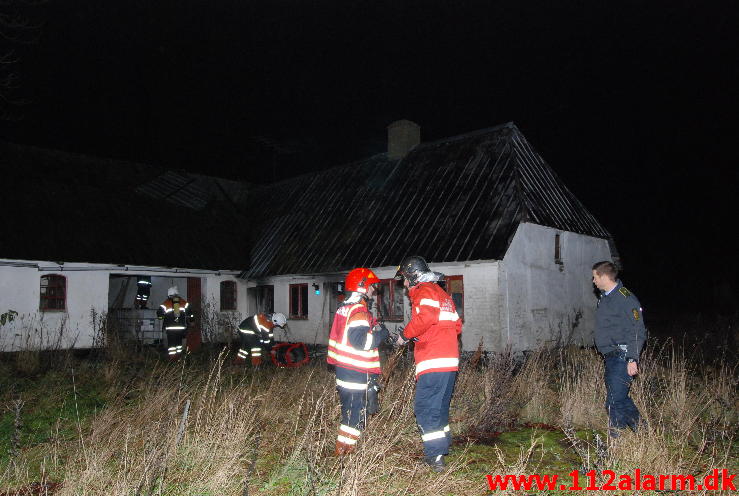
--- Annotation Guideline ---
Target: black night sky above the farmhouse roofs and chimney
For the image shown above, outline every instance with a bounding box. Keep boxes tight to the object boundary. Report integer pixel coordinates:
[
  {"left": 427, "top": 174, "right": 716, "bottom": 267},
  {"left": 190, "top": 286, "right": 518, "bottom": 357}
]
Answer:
[{"left": 0, "top": 0, "right": 739, "bottom": 308}]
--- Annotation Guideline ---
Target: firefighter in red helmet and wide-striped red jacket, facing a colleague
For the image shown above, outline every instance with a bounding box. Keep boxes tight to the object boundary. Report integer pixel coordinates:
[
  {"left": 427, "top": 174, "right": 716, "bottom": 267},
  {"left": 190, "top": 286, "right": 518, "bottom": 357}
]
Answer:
[{"left": 327, "top": 267, "right": 388, "bottom": 455}]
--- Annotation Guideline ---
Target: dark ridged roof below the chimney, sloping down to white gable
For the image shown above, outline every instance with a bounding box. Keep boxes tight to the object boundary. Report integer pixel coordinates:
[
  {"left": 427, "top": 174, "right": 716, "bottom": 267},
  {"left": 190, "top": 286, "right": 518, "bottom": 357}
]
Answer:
[{"left": 242, "top": 123, "right": 610, "bottom": 278}]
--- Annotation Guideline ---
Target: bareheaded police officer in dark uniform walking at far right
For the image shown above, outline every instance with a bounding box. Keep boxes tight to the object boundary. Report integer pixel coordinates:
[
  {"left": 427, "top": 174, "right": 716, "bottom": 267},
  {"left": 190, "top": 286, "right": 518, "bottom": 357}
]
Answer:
[{"left": 593, "top": 261, "right": 646, "bottom": 437}]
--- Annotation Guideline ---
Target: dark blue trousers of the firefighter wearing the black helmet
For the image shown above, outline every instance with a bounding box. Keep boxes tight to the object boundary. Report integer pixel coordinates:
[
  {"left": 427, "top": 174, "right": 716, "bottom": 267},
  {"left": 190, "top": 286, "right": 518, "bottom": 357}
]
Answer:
[{"left": 414, "top": 372, "right": 457, "bottom": 458}]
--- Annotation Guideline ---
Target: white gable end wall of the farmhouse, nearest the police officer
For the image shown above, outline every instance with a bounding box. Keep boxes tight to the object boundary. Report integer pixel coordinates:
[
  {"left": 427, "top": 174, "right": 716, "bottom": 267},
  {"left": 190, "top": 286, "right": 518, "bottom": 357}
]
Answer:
[{"left": 500, "top": 223, "right": 611, "bottom": 351}]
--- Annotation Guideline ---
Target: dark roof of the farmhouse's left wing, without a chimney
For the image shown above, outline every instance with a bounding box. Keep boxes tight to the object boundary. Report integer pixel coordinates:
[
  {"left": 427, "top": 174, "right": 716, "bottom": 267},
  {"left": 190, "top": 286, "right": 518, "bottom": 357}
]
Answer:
[{"left": 0, "top": 141, "right": 249, "bottom": 270}]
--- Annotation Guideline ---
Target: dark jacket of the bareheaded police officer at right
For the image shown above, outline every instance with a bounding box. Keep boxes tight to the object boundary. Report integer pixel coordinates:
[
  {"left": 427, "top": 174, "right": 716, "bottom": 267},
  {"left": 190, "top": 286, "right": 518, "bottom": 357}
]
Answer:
[{"left": 595, "top": 281, "right": 647, "bottom": 360}]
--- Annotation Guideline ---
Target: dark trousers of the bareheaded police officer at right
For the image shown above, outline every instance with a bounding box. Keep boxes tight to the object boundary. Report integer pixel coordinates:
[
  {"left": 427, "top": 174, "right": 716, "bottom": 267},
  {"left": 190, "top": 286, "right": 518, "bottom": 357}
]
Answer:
[{"left": 605, "top": 356, "right": 641, "bottom": 430}]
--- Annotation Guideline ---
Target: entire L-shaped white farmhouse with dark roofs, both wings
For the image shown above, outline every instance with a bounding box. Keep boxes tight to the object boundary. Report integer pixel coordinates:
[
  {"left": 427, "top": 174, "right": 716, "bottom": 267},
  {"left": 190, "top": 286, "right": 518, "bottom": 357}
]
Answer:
[{"left": 0, "top": 120, "right": 617, "bottom": 351}]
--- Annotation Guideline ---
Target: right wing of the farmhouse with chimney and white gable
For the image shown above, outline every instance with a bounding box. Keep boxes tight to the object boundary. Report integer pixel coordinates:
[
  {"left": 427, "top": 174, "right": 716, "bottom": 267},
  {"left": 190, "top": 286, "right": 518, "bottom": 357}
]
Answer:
[{"left": 241, "top": 120, "right": 616, "bottom": 351}]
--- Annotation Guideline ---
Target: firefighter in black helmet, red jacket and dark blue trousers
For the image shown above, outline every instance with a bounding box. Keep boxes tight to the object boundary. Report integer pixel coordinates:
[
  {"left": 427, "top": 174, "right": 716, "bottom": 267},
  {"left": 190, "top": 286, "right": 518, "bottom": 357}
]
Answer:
[{"left": 396, "top": 256, "right": 462, "bottom": 472}]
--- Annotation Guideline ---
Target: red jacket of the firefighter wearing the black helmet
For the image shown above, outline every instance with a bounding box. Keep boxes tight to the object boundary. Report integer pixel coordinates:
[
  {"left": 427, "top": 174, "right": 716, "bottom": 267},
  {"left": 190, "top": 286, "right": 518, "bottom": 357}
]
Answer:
[{"left": 403, "top": 282, "right": 462, "bottom": 378}]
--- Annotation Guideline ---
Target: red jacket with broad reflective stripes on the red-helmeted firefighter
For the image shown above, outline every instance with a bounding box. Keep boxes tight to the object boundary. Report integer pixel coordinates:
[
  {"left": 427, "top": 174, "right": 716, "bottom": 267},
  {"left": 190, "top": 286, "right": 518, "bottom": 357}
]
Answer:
[{"left": 327, "top": 302, "right": 385, "bottom": 374}]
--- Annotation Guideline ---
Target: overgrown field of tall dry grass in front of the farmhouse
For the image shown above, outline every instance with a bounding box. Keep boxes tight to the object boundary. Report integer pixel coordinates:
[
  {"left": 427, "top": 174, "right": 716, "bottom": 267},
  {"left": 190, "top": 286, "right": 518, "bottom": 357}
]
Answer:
[{"left": 0, "top": 334, "right": 739, "bottom": 496}]
